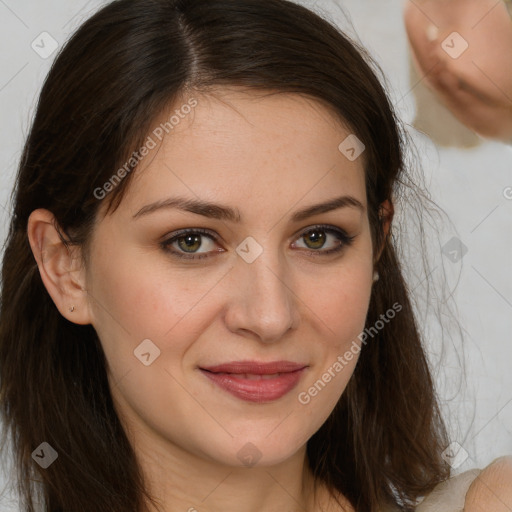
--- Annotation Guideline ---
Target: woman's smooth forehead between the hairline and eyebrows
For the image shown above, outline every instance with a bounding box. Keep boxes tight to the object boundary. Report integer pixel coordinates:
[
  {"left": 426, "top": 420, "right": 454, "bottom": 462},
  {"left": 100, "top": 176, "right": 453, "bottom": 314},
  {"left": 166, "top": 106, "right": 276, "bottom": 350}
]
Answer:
[{"left": 106, "top": 89, "right": 366, "bottom": 220}]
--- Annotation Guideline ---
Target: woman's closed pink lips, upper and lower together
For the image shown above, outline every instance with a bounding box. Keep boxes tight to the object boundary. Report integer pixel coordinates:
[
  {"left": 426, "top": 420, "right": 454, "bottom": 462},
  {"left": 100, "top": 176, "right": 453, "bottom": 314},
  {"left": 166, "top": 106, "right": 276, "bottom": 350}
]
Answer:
[{"left": 200, "top": 361, "right": 307, "bottom": 403}]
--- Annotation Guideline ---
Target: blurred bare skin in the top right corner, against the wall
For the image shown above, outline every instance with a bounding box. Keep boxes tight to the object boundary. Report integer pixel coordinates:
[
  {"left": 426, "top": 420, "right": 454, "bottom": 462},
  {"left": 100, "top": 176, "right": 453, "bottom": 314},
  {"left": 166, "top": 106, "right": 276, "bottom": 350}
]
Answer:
[{"left": 404, "top": 0, "right": 512, "bottom": 142}]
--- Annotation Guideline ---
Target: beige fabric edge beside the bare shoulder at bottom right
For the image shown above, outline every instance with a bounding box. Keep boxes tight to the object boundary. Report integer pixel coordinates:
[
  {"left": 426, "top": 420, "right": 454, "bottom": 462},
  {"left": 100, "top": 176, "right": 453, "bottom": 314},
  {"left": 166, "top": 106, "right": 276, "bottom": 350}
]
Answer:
[{"left": 416, "top": 469, "right": 482, "bottom": 512}]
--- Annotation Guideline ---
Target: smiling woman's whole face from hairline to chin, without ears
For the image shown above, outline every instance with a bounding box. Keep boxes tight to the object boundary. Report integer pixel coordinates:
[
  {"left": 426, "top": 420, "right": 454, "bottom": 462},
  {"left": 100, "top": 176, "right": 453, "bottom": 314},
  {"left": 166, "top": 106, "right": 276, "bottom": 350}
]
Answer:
[{"left": 86, "top": 90, "right": 373, "bottom": 466}]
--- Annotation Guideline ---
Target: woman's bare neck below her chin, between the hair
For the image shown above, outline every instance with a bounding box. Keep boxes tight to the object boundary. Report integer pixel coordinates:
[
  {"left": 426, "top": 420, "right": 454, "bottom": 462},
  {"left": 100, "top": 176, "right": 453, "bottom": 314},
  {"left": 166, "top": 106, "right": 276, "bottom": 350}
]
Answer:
[{"left": 137, "top": 432, "right": 316, "bottom": 512}]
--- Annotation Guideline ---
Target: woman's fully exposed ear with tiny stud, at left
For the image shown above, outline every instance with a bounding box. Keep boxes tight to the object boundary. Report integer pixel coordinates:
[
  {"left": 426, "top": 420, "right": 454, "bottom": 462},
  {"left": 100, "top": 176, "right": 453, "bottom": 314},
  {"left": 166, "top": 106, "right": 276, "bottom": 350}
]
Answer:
[{"left": 27, "top": 208, "right": 92, "bottom": 325}]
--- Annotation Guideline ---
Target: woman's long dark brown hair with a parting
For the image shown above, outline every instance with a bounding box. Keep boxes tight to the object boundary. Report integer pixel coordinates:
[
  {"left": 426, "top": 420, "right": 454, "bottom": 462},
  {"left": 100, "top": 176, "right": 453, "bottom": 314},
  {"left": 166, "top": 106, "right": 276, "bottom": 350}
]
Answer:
[{"left": 0, "top": 0, "right": 449, "bottom": 512}]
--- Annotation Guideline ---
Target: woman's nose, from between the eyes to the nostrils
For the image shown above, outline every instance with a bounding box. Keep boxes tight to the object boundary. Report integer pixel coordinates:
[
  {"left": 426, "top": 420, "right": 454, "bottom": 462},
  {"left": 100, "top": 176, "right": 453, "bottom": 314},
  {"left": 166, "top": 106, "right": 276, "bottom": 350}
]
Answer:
[{"left": 225, "top": 244, "right": 300, "bottom": 343}]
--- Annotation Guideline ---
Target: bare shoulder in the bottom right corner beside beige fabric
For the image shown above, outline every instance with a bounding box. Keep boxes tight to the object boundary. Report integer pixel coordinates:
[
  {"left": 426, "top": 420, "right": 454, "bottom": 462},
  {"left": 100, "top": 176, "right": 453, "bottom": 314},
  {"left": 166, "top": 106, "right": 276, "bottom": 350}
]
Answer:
[{"left": 464, "top": 455, "right": 512, "bottom": 512}]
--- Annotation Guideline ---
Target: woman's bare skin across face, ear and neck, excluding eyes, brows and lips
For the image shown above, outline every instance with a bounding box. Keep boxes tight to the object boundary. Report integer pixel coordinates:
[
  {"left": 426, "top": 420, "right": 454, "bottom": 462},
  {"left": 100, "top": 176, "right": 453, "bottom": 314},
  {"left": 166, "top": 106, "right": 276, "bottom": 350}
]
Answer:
[{"left": 28, "top": 89, "right": 392, "bottom": 512}]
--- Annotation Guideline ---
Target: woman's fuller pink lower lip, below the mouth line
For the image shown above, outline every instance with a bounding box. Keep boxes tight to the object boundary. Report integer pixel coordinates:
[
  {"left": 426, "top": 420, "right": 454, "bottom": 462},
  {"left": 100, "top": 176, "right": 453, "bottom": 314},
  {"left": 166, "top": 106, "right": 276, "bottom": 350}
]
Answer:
[{"left": 200, "top": 368, "right": 306, "bottom": 403}]
